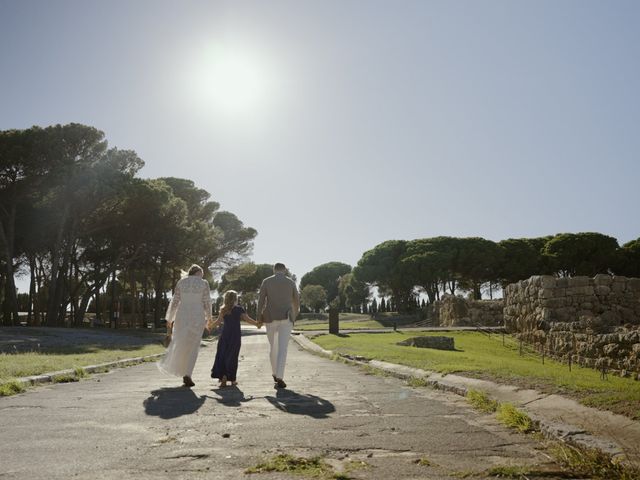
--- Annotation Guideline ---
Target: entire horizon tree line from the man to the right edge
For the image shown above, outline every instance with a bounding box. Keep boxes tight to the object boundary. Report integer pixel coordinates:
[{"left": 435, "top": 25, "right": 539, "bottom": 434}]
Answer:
[{"left": 236, "top": 232, "right": 640, "bottom": 313}]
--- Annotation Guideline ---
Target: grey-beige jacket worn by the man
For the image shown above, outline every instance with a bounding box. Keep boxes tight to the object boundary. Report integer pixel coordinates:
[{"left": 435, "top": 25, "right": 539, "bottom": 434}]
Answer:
[{"left": 258, "top": 272, "right": 300, "bottom": 323}]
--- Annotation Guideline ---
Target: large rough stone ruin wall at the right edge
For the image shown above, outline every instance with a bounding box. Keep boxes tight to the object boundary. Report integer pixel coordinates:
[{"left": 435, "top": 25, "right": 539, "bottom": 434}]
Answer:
[{"left": 504, "top": 275, "right": 640, "bottom": 379}]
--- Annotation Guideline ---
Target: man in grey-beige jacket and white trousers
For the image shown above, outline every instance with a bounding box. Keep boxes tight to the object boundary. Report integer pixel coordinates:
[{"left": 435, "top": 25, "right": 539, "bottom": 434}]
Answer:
[{"left": 257, "top": 263, "right": 300, "bottom": 388}]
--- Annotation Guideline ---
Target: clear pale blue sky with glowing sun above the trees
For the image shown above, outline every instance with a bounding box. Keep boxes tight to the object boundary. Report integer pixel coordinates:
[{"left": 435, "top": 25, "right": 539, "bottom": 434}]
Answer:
[{"left": 0, "top": 0, "right": 640, "bottom": 284}]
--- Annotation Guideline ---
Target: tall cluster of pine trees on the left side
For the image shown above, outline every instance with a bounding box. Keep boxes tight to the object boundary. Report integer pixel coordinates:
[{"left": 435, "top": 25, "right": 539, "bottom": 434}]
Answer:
[{"left": 0, "top": 123, "right": 257, "bottom": 325}]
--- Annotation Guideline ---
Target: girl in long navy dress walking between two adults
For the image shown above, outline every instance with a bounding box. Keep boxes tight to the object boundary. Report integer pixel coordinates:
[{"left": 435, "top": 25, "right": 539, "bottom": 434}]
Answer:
[{"left": 211, "top": 290, "right": 262, "bottom": 387}]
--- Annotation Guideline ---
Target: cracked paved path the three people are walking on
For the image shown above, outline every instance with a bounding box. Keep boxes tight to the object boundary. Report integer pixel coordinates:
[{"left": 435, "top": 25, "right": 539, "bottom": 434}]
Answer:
[{"left": 0, "top": 331, "right": 564, "bottom": 480}]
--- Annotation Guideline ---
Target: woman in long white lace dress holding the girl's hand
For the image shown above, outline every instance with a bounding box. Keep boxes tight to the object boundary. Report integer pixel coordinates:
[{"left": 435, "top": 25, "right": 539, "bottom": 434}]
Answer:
[{"left": 158, "top": 265, "right": 211, "bottom": 387}]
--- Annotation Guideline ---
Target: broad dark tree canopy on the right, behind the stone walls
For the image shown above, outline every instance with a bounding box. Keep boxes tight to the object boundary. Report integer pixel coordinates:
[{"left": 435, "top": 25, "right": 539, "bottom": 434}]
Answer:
[{"left": 353, "top": 232, "right": 640, "bottom": 311}]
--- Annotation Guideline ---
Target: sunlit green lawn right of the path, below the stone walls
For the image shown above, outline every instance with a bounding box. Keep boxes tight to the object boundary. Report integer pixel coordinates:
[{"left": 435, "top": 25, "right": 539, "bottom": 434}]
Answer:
[{"left": 313, "top": 332, "right": 640, "bottom": 420}]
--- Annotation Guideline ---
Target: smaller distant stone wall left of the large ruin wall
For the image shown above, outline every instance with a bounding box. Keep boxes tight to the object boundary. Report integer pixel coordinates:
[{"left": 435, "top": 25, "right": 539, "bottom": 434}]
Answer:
[{"left": 433, "top": 295, "right": 503, "bottom": 327}]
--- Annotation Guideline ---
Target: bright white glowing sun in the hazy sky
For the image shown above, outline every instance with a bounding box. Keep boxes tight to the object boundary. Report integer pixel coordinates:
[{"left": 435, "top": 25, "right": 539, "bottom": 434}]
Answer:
[{"left": 191, "top": 45, "right": 271, "bottom": 115}]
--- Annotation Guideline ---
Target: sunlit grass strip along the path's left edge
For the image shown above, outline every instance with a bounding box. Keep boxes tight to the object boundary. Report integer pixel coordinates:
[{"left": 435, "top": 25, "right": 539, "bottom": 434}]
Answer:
[{"left": 0, "top": 344, "right": 164, "bottom": 384}]
